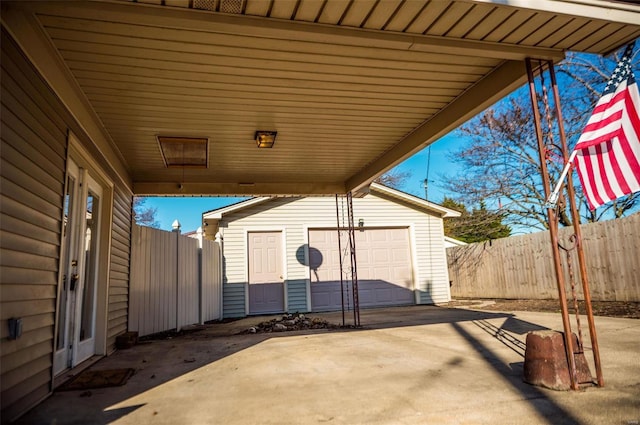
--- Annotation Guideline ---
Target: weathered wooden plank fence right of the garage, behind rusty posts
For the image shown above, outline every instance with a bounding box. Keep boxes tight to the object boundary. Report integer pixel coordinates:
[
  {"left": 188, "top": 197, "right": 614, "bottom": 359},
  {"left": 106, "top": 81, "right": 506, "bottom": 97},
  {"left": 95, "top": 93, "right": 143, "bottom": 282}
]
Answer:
[{"left": 447, "top": 213, "right": 640, "bottom": 301}]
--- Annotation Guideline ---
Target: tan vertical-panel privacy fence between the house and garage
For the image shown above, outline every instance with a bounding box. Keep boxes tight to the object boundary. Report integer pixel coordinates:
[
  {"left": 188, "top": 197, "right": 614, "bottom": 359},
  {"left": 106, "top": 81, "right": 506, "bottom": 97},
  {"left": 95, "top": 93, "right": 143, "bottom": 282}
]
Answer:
[{"left": 129, "top": 225, "right": 222, "bottom": 336}]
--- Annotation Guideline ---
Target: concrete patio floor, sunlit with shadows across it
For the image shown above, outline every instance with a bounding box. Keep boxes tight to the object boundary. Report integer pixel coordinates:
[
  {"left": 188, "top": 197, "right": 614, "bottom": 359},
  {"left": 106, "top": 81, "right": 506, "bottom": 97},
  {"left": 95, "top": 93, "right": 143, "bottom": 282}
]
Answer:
[{"left": 18, "top": 306, "right": 640, "bottom": 425}]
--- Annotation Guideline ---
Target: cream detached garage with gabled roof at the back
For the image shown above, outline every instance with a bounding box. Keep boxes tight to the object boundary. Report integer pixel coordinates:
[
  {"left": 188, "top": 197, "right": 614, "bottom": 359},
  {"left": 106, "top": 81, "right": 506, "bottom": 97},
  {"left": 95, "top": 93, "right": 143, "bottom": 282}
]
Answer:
[{"left": 203, "top": 183, "right": 459, "bottom": 317}]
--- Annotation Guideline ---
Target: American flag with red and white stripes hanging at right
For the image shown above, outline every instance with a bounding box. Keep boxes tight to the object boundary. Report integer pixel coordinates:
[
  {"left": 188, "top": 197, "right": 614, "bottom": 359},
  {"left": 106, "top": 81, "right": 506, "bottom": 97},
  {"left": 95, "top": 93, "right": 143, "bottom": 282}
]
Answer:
[{"left": 574, "top": 42, "right": 640, "bottom": 210}]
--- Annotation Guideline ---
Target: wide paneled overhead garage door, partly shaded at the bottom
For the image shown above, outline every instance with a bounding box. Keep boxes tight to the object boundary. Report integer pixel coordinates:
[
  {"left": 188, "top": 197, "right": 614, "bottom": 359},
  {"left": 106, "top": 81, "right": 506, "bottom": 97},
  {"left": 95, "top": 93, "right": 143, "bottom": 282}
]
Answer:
[{"left": 309, "top": 228, "right": 415, "bottom": 311}]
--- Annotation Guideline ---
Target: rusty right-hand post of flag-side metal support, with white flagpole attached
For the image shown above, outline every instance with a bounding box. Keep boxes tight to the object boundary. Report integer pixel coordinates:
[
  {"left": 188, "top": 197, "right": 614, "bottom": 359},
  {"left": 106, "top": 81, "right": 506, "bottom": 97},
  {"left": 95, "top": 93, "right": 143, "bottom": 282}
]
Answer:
[{"left": 549, "top": 62, "right": 604, "bottom": 387}]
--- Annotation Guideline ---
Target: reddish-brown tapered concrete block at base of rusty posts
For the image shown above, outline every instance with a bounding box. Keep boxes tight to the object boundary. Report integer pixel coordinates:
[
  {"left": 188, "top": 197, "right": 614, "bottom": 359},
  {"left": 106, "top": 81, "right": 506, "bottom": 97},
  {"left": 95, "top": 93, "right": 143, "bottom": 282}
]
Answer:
[{"left": 524, "top": 330, "right": 593, "bottom": 391}]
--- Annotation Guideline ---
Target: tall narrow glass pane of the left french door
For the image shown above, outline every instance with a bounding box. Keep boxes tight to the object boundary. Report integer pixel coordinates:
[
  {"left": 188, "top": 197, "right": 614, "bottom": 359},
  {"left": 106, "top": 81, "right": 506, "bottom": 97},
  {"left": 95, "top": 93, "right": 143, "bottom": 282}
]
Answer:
[{"left": 56, "top": 176, "right": 76, "bottom": 350}]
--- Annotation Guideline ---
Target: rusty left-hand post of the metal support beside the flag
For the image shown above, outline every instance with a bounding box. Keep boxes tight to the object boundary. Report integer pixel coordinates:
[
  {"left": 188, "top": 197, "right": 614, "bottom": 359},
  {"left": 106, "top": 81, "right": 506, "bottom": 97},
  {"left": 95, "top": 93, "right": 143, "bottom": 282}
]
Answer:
[{"left": 525, "top": 58, "right": 578, "bottom": 390}]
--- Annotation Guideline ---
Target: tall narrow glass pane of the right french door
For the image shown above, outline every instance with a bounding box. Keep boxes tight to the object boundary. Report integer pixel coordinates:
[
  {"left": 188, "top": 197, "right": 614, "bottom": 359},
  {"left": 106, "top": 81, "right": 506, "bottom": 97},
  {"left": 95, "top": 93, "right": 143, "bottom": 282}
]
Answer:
[{"left": 80, "top": 190, "right": 100, "bottom": 341}]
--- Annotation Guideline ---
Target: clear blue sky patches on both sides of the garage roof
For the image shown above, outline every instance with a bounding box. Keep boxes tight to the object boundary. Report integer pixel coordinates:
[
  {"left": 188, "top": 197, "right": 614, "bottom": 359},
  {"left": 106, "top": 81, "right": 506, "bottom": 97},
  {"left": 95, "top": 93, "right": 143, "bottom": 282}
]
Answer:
[{"left": 145, "top": 133, "right": 462, "bottom": 233}]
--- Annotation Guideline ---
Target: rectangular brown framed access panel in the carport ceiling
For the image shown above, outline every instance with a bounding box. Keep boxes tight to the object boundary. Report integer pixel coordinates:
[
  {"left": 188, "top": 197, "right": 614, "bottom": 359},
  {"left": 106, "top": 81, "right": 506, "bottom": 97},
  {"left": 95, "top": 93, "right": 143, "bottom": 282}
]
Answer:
[{"left": 158, "top": 136, "right": 209, "bottom": 168}]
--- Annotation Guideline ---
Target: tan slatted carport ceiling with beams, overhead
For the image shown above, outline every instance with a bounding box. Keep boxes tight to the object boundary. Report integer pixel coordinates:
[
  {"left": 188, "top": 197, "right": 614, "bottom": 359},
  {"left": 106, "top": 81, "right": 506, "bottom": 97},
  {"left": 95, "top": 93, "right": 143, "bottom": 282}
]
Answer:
[{"left": 3, "top": 0, "right": 640, "bottom": 195}]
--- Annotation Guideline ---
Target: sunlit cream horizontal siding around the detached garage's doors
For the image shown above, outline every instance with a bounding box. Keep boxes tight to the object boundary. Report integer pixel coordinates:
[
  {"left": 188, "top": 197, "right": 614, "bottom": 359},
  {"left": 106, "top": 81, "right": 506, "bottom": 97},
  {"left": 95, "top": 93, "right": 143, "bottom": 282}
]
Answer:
[{"left": 220, "top": 194, "right": 449, "bottom": 312}]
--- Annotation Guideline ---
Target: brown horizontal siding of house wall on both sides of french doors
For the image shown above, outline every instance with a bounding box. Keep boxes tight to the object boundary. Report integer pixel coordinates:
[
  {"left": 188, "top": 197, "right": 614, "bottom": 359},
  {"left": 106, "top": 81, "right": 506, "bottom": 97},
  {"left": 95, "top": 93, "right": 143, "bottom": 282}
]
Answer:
[{"left": 0, "top": 27, "right": 132, "bottom": 421}]
